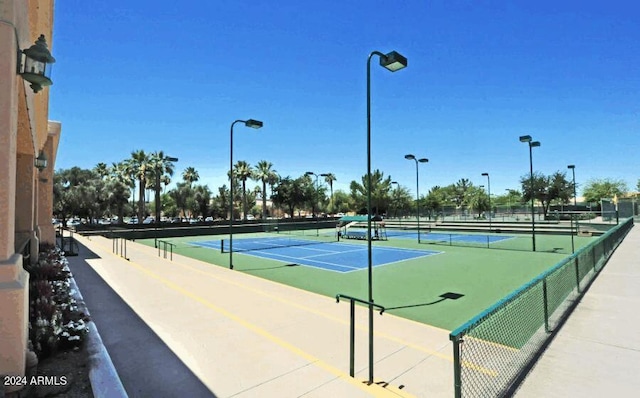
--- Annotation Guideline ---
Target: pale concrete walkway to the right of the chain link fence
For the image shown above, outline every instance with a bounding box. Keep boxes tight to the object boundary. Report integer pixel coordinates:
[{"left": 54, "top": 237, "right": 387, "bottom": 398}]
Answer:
[{"left": 516, "top": 226, "right": 640, "bottom": 398}]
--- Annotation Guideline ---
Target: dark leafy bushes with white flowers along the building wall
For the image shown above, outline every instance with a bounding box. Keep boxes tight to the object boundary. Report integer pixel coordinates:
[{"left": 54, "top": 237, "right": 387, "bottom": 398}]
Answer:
[{"left": 25, "top": 246, "right": 89, "bottom": 360}]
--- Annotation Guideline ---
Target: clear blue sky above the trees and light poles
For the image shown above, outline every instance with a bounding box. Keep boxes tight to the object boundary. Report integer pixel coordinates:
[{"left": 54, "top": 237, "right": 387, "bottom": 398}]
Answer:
[{"left": 50, "top": 0, "right": 640, "bottom": 199}]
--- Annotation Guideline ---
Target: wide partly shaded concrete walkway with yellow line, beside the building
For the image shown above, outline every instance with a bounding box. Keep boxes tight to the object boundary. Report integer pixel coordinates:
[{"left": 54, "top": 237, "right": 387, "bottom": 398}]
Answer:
[{"left": 72, "top": 235, "right": 453, "bottom": 398}]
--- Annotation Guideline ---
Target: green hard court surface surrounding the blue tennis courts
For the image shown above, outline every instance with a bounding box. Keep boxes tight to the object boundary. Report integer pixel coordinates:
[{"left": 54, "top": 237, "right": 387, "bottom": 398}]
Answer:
[{"left": 138, "top": 229, "right": 595, "bottom": 330}]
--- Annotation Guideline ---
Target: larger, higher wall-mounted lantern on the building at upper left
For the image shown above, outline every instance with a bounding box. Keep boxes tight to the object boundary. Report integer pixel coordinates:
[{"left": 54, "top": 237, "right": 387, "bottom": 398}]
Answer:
[{"left": 18, "top": 35, "right": 56, "bottom": 93}]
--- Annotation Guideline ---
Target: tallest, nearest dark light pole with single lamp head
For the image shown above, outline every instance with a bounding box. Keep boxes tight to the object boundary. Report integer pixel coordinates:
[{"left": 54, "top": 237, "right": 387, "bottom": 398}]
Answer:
[{"left": 367, "top": 51, "right": 407, "bottom": 384}]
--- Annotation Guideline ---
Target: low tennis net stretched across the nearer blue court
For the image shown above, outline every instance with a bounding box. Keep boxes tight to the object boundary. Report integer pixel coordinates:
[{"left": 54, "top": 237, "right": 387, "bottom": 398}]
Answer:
[{"left": 220, "top": 233, "right": 339, "bottom": 253}]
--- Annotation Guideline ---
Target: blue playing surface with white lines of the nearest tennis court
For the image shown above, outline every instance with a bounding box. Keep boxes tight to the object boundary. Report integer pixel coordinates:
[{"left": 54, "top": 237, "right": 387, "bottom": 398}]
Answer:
[{"left": 191, "top": 238, "right": 441, "bottom": 272}]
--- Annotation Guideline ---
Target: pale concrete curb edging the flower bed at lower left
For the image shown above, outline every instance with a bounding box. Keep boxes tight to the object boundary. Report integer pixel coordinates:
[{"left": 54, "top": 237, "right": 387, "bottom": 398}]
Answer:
[{"left": 69, "top": 277, "right": 129, "bottom": 398}]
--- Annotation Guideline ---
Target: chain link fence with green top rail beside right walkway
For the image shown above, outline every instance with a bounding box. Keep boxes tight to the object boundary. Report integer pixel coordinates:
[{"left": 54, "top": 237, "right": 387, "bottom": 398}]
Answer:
[{"left": 449, "top": 218, "right": 633, "bottom": 397}]
